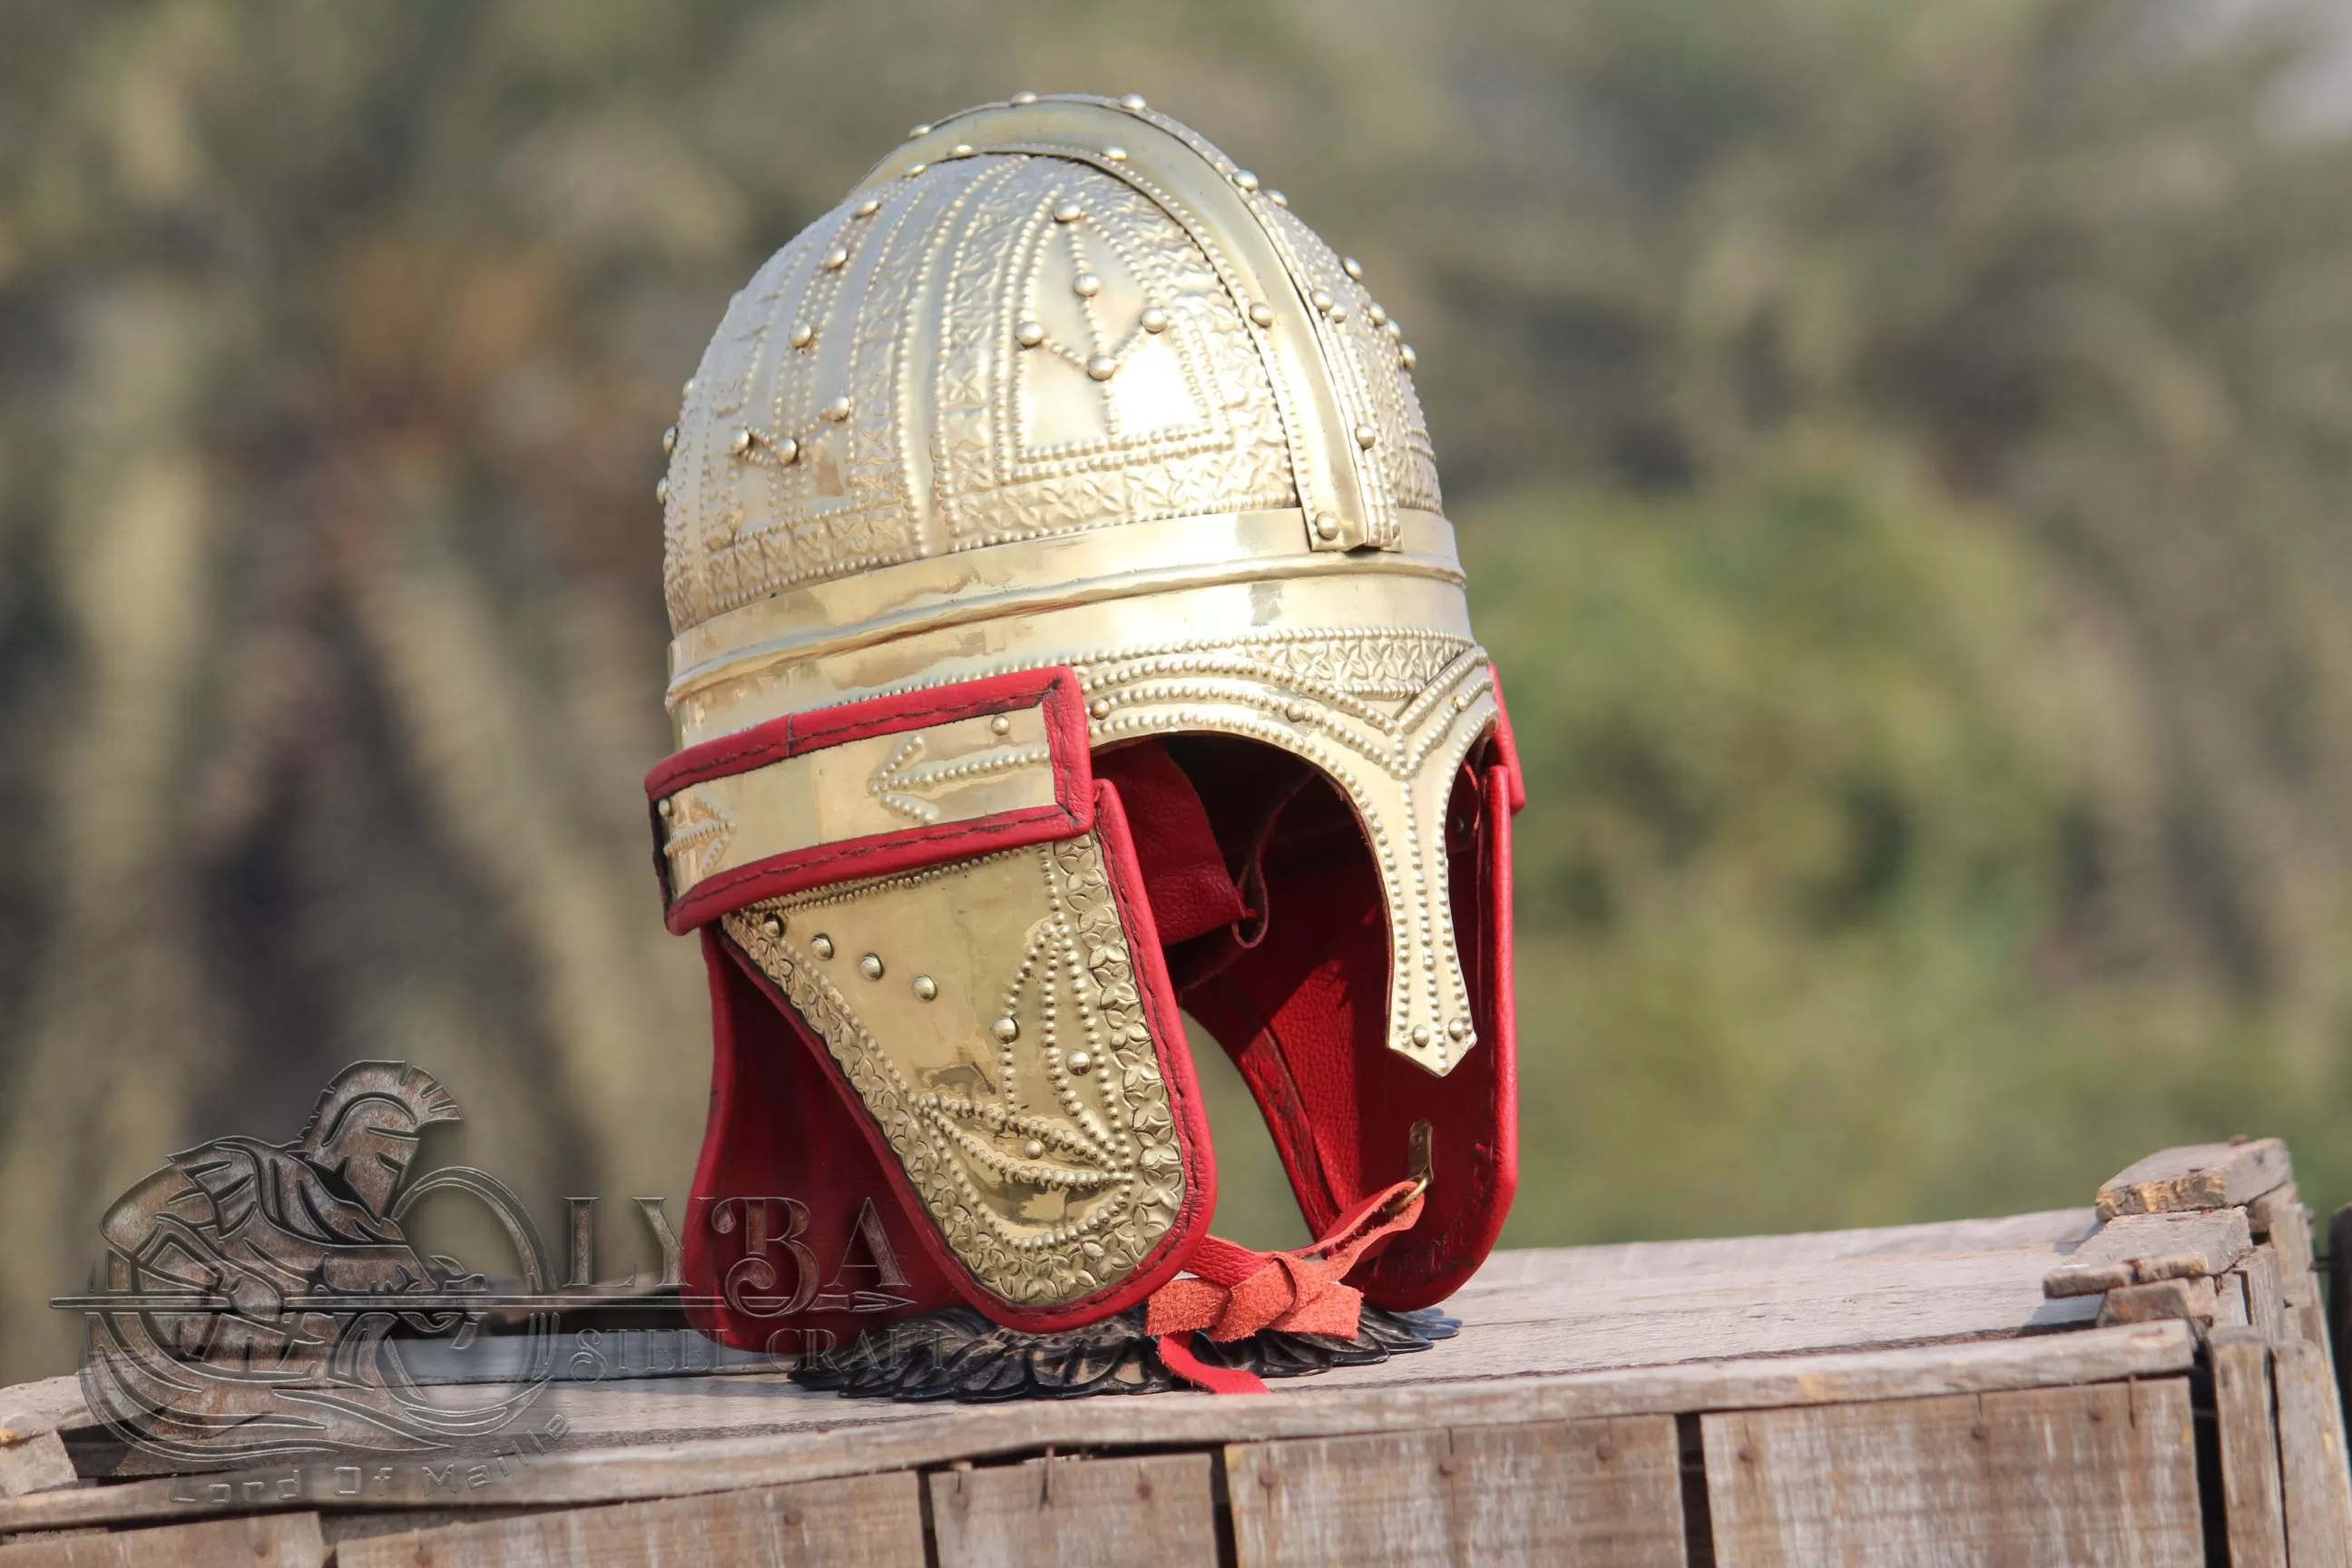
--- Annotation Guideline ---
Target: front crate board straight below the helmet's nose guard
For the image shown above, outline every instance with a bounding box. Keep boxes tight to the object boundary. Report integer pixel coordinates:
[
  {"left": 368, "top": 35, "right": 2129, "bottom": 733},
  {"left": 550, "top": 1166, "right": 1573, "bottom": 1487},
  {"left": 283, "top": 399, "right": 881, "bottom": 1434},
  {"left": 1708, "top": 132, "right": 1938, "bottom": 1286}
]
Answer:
[{"left": 1225, "top": 1416, "right": 1686, "bottom": 1568}]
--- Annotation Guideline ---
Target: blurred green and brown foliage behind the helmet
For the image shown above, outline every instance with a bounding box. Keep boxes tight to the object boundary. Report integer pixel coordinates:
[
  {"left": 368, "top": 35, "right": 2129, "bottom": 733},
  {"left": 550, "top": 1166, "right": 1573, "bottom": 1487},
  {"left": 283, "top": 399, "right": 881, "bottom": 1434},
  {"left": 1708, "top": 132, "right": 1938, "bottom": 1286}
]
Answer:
[{"left": 0, "top": 0, "right": 2352, "bottom": 1380}]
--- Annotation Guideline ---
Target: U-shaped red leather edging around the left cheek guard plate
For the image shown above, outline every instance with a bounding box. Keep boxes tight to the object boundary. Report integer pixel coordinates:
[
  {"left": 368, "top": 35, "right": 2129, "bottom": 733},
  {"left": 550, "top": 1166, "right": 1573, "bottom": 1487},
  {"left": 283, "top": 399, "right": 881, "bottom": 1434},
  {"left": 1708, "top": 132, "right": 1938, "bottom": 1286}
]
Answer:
[{"left": 703, "top": 780, "right": 1216, "bottom": 1333}]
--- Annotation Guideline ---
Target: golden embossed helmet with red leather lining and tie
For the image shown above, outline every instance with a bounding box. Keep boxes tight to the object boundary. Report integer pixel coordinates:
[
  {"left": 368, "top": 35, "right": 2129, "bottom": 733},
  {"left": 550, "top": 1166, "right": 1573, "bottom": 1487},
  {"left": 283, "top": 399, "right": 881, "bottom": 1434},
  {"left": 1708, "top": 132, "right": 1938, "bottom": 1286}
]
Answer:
[{"left": 647, "top": 94, "right": 1524, "bottom": 1372}]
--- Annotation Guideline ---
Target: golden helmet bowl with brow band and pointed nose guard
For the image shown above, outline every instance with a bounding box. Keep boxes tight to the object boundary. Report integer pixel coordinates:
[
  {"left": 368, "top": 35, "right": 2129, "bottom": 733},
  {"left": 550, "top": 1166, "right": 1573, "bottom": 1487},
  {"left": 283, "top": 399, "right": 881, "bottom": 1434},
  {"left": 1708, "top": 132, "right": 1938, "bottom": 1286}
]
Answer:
[{"left": 666, "top": 94, "right": 1496, "bottom": 1091}]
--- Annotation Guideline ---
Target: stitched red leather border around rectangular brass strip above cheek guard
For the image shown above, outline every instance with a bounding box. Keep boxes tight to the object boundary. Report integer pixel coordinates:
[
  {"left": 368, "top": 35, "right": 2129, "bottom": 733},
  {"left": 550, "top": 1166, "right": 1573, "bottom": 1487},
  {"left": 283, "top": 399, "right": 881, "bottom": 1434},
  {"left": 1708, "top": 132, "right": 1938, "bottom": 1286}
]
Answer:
[{"left": 644, "top": 668, "right": 1093, "bottom": 936}]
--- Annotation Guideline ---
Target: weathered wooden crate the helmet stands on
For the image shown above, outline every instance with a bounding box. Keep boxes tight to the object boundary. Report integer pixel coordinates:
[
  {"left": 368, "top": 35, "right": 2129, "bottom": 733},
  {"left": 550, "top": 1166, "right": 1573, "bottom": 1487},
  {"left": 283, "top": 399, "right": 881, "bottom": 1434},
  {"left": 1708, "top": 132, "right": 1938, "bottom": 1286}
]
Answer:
[{"left": 0, "top": 1145, "right": 2352, "bottom": 1568}]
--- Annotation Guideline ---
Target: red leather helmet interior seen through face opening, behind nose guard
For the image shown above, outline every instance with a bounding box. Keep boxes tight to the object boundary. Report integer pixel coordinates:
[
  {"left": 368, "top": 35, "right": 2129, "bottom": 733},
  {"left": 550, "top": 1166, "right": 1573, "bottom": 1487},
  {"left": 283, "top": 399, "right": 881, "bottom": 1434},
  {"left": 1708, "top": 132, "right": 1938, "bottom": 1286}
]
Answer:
[{"left": 1096, "top": 736, "right": 1514, "bottom": 1307}]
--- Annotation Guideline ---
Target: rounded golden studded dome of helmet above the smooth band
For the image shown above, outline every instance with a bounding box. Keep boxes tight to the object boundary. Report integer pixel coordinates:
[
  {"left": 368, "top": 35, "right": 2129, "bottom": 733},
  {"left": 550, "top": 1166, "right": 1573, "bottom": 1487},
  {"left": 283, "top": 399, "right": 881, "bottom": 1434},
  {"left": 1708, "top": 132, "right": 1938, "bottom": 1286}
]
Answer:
[{"left": 666, "top": 88, "right": 1439, "bottom": 630}]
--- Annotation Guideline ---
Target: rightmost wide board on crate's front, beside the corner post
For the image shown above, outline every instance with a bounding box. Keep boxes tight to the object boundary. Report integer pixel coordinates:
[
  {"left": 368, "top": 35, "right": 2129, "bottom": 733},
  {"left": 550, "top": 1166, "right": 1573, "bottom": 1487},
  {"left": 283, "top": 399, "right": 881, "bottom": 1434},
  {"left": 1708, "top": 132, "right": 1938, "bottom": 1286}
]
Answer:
[{"left": 1700, "top": 1377, "right": 2204, "bottom": 1568}]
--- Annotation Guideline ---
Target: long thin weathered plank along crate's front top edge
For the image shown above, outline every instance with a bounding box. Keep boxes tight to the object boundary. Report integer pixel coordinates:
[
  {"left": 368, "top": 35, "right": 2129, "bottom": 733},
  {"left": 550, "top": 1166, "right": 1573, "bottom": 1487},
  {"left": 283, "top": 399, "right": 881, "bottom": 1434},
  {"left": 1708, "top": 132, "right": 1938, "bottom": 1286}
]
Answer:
[{"left": 0, "top": 1324, "right": 2197, "bottom": 1535}]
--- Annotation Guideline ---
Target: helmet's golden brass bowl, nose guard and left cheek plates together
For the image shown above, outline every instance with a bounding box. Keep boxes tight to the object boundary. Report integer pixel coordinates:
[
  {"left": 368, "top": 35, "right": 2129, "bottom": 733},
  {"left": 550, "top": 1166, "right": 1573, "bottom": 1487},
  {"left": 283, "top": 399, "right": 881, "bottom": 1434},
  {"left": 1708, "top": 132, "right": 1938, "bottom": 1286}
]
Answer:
[{"left": 656, "top": 94, "right": 1498, "bottom": 1354}]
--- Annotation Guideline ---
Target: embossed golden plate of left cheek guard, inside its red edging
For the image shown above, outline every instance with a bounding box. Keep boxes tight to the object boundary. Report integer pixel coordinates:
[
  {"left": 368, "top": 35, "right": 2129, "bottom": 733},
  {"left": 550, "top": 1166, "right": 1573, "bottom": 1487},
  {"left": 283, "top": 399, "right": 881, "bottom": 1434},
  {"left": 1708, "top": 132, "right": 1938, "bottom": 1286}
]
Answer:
[{"left": 724, "top": 832, "right": 1183, "bottom": 1307}]
